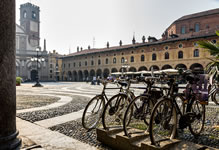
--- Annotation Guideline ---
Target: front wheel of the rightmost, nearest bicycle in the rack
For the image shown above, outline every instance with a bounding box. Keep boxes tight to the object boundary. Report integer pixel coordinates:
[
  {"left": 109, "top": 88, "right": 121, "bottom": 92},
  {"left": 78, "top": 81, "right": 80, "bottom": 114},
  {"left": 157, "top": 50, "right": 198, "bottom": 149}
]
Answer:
[{"left": 149, "top": 98, "right": 177, "bottom": 146}]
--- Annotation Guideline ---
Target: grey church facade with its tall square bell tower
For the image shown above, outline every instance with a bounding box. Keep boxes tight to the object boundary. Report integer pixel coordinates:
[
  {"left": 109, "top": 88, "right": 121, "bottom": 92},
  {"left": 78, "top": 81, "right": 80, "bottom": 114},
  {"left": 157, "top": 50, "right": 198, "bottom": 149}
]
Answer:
[{"left": 16, "top": 3, "right": 49, "bottom": 81}]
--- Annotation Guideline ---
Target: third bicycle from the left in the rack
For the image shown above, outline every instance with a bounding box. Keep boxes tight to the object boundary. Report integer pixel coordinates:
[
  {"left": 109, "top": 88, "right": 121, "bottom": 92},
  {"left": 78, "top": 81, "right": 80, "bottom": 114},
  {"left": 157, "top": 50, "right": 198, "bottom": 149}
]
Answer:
[{"left": 123, "top": 77, "right": 163, "bottom": 137}]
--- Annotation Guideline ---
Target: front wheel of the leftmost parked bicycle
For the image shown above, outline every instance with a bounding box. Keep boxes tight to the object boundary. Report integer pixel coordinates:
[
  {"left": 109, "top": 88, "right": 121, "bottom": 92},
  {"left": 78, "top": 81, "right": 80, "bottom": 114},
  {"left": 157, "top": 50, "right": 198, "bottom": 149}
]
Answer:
[{"left": 82, "top": 95, "right": 105, "bottom": 130}]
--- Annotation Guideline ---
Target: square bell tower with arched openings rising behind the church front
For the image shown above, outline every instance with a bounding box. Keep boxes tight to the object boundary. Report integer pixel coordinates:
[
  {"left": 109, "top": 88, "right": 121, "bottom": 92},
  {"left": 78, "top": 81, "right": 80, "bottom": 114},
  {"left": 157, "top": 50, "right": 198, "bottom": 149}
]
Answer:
[{"left": 20, "top": 3, "right": 40, "bottom": 47}]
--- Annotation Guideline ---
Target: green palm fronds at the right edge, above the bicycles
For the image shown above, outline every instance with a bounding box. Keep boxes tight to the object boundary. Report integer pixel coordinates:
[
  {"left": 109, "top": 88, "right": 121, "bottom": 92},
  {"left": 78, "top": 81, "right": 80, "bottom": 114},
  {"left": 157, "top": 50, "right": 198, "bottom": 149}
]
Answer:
[{"left": 198, "top": 31, "right": 219, "bottom": 79}]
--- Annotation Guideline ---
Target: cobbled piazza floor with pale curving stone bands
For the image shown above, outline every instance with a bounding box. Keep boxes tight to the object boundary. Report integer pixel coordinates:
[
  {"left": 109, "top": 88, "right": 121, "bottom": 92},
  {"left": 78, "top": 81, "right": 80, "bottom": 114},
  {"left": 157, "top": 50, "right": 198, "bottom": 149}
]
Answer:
[{"left": 17, "top": 82, "right": 219, "bottom": 149}]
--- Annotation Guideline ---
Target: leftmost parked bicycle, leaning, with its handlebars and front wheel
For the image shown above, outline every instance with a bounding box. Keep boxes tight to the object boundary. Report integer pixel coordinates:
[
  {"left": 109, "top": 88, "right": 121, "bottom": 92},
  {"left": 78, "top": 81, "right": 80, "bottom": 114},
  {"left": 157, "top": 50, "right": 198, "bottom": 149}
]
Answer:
[{"left": 82, "top": 80, "right": 124, "bottom": 130}]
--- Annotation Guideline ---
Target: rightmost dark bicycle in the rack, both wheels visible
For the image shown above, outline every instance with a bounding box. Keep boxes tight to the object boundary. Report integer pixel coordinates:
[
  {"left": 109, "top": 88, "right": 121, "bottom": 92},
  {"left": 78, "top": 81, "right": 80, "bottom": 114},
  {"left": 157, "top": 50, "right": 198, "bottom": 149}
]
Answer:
[{"left": 149, "top": 75, "right": 205, "bottom": 146}]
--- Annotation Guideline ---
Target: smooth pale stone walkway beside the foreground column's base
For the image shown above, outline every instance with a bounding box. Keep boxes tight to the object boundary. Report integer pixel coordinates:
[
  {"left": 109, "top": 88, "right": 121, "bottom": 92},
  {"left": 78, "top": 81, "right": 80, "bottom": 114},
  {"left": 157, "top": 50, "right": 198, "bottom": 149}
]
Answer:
[{"left": 17, "top": 118, "right": 97, "bottom": 150}]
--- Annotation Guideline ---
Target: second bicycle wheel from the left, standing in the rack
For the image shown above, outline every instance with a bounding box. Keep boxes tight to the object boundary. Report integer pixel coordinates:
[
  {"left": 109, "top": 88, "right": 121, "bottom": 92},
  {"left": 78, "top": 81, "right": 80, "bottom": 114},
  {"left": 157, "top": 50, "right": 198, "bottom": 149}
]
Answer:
[{"left": 102, "top": 93, "right": 131, "bottom": 130}]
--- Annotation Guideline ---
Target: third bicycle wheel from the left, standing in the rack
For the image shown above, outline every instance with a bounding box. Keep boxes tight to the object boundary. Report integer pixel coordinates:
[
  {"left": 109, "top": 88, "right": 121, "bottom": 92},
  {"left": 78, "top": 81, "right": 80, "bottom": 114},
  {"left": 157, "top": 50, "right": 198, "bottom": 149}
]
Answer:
[{"left": 123, "top": 95, "right": 153, "bottom": 137}]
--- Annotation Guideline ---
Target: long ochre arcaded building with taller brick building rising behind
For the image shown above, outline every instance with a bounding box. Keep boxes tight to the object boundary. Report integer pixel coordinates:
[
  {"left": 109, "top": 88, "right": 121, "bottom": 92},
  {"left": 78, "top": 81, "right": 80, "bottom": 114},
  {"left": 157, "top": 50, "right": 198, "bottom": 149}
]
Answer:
[{"left": 62, "top": 9, "right": 219, "bottom": 81}]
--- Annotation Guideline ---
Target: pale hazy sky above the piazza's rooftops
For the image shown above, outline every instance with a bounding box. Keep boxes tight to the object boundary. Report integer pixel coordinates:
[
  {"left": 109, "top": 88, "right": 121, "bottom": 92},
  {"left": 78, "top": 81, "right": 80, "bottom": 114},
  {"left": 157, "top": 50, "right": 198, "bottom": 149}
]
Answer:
[{"left": 16, "top": 0, "right": 219, "bottom": 54}]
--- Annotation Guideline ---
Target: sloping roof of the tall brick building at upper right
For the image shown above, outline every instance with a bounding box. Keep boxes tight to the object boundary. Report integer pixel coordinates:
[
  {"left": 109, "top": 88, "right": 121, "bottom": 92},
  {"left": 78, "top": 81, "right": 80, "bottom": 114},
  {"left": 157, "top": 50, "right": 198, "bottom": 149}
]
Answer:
[{"left": 176, "top": 8, "right": 219, "bottom": 21}]
